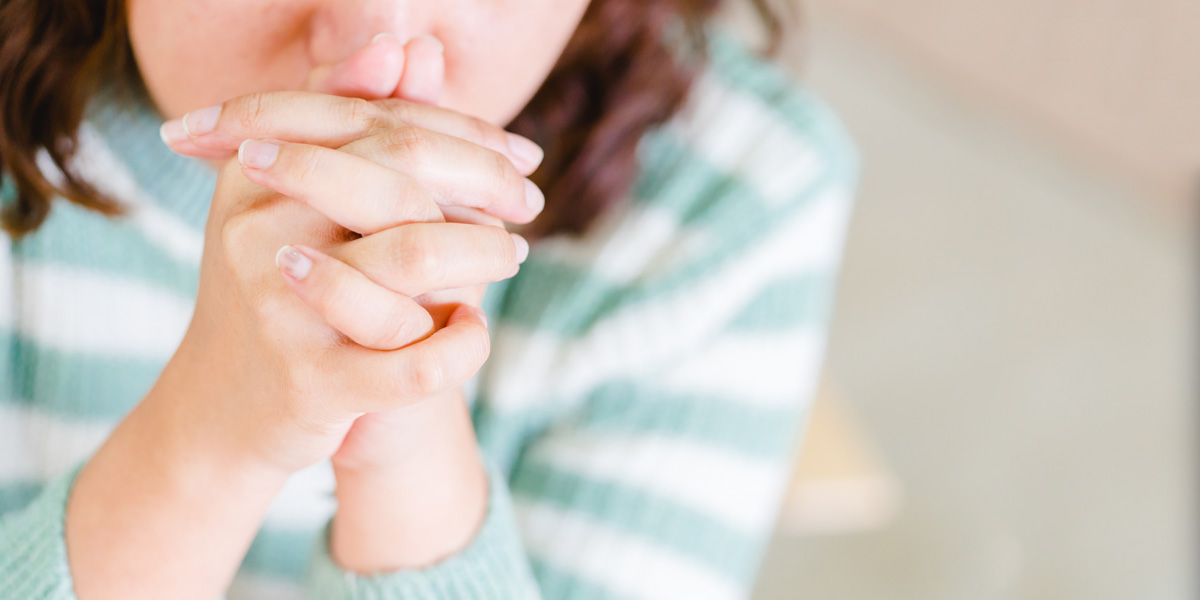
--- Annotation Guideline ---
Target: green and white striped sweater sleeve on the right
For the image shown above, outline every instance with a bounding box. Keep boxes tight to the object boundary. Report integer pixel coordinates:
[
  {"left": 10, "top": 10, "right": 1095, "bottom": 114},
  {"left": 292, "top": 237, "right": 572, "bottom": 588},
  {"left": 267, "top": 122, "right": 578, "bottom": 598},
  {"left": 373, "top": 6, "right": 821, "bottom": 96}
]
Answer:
[{"left": 480, "top": 55, "right": 857, "bottom": 600}]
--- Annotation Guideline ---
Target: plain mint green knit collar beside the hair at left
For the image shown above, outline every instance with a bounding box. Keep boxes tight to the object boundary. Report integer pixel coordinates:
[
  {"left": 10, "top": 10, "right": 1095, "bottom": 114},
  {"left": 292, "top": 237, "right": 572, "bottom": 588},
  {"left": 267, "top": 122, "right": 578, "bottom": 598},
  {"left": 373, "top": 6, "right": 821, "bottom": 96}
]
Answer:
[{"left": 84, "top": 89, "right": 217, "bottom": 232}]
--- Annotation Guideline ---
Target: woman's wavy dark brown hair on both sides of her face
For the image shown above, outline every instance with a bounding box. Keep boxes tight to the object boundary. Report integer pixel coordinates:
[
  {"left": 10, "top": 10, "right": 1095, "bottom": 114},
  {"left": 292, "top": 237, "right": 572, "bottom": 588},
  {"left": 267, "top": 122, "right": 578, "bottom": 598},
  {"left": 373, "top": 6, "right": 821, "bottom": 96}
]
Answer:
[{"left": 0, "top": 0, "right": 782, "bottom": 238}]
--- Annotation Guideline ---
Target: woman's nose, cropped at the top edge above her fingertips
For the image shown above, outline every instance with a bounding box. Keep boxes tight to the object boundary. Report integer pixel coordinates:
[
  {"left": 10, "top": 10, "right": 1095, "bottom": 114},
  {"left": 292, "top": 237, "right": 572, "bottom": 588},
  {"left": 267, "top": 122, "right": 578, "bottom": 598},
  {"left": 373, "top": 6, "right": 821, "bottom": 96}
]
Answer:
[{"left": 308, "top": 0, "right": 437, "bottom": 65}]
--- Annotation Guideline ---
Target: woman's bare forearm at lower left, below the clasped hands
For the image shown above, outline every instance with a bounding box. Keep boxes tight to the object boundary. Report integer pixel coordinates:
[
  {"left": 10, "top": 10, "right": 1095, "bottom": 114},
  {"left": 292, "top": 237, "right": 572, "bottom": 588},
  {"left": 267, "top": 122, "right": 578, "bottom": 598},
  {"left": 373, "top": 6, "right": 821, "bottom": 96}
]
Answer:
[{"left": 65, "top": 350, "right": 286, "bottom": 600}]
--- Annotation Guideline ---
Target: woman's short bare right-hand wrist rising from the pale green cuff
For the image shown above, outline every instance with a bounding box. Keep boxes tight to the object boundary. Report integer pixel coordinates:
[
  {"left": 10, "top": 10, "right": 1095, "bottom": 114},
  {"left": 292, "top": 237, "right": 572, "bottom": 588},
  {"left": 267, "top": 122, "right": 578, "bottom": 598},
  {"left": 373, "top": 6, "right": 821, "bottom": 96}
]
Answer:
[{"left": 330, "top": 390, "right": 488, "bottom": 572}]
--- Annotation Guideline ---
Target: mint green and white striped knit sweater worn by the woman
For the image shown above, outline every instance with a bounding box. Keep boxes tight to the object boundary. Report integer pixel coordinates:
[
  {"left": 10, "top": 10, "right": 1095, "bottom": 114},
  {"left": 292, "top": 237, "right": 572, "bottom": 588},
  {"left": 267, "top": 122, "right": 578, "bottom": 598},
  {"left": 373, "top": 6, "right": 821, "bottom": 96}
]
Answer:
[{"left": 0, "top": 31, "right": 857, "bottom": 600}]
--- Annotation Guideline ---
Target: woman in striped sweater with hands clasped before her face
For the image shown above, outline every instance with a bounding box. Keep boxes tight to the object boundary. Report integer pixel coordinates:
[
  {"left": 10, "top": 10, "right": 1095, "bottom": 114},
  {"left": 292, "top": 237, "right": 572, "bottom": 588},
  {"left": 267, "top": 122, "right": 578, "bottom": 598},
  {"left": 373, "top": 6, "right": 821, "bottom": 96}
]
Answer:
[{"left": 0, "top": 0, "right": 854, "bottom": 600}]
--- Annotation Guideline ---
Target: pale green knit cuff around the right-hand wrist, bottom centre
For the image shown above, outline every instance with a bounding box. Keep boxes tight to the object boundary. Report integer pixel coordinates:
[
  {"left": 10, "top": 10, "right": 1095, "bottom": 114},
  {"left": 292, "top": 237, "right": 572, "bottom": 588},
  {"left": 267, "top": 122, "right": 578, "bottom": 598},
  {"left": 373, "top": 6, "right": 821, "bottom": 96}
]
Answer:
[{"left": 306, "top": 455, "right": 540, "bottom": 600}]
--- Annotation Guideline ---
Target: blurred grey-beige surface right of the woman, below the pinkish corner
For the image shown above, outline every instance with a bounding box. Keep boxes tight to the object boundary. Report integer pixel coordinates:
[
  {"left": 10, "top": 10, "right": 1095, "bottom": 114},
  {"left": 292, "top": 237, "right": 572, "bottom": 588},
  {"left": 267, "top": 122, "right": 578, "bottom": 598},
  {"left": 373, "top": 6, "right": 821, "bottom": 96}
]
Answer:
[{"left": 754, "top": 7, "right": 1200, "bottom": 600}]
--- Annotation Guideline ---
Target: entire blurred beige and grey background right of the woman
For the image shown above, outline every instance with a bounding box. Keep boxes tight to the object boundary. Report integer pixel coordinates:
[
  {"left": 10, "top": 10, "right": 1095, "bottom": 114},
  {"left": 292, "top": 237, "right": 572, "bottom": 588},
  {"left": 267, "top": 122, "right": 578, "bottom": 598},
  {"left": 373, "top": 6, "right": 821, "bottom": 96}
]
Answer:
[{"left": 733, "top": 0, "right": 1200, "bottom": 600}]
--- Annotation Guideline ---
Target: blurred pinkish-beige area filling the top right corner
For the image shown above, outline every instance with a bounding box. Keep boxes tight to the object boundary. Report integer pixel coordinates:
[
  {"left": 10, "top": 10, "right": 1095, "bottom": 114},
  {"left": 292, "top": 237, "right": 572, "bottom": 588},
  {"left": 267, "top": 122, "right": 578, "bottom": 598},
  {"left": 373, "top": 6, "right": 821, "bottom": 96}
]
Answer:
[{"left": 802, "top": 0, "right": 1200, "bottom": 212}]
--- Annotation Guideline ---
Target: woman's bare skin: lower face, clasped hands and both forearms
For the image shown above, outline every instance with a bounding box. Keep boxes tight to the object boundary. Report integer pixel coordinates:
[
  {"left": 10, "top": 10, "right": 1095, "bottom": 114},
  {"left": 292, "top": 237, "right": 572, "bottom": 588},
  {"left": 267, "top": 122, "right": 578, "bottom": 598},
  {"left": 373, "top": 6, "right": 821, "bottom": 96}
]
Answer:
[{"left": 66, "top": 0, "right": 587, "bottom": 600}]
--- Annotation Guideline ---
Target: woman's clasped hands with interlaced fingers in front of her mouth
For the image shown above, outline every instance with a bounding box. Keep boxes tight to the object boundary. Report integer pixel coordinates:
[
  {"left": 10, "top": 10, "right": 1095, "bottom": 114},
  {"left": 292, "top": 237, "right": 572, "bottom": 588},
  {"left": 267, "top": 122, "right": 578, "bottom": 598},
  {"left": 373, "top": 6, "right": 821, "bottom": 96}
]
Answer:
[{"left": 163, "top": 36, "right": 545, "bottom": 472}]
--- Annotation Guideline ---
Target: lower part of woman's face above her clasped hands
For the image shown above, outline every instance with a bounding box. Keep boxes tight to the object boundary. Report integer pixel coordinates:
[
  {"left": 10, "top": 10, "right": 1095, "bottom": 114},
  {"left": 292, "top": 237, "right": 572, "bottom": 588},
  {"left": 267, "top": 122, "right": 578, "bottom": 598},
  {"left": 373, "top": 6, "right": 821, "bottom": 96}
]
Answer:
[{"left": 128, "top": 0, "right": 587, "bottom": 125}]
